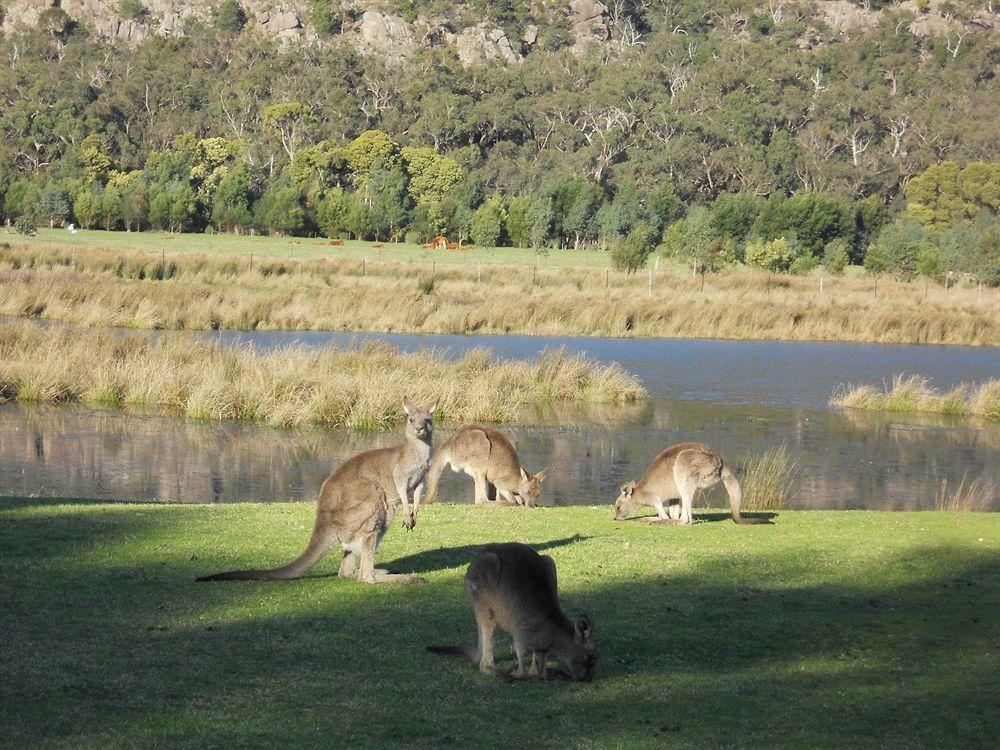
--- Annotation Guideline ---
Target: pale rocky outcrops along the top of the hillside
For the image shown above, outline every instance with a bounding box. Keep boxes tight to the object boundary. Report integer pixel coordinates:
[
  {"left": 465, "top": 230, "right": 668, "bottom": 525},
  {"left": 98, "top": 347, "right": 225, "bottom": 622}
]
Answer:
[{"left": 0, "top": 0, "right": 997, "bottom": 65}]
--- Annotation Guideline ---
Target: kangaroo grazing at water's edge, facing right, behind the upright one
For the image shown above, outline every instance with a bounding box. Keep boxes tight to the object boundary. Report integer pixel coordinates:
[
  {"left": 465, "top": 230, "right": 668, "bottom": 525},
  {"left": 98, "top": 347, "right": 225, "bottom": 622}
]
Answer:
[{"left": 426, "top": 424, "right": 549, "bottom": 507}]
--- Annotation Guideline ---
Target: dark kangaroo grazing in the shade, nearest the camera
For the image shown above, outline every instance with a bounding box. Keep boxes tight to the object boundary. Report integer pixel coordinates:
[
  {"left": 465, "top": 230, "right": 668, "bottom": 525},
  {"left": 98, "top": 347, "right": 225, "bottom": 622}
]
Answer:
[{"left": 427, "top": 542, "right": 597, "bottom": 682}]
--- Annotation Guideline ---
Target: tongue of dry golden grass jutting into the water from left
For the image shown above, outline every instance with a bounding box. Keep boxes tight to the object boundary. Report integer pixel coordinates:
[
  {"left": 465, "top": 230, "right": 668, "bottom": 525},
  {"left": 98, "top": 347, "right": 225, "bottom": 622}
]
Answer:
[{"left": 0, "top": 323, "right": 644, "bottom": 429}]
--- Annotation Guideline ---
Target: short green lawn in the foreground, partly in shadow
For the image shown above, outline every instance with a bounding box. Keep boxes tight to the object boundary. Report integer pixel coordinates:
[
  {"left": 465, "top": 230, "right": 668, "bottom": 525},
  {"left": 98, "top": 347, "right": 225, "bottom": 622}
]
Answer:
[{"left": 0, "top": 499, "right": 1000, "bottom": 748}]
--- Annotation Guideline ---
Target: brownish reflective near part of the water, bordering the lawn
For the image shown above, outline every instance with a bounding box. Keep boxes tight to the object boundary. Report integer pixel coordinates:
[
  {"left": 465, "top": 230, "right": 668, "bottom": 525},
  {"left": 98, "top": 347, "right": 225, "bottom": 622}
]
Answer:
[{"left": 0, "top": 398, "right": 1000, "bottom": 509}]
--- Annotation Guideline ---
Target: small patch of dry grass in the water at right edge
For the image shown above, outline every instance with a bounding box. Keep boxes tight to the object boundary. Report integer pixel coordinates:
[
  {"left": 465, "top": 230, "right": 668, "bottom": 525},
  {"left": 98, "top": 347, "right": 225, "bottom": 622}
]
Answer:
[{"left": 830, "top": 375, "right": 1000, "bottom": 420}]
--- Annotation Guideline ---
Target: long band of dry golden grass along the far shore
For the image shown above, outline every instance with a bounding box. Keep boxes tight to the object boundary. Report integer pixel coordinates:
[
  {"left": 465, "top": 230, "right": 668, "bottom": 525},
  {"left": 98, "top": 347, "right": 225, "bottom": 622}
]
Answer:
[{"left": 0, "top": 246, "right": 1000, "bottom": 344}]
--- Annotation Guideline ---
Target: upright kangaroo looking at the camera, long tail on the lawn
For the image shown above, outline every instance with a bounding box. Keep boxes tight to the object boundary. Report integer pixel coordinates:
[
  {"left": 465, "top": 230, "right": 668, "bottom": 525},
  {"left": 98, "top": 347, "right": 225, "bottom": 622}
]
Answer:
[{"left": 197, "top": 398, "right": 437, "bottom": 583}]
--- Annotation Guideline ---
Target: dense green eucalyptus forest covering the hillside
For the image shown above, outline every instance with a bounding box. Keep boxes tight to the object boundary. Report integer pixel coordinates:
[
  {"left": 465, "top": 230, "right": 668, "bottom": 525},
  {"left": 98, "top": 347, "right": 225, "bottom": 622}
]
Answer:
[{"left": 0, "top": 0, "right": 1000, "bottom": 283}]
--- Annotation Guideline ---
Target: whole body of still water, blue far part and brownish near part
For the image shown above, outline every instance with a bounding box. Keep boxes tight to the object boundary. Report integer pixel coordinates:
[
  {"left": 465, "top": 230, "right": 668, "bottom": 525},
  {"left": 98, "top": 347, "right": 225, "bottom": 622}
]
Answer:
[{"left": 0, "top": 332, "right": 1000, "bottom": 509}]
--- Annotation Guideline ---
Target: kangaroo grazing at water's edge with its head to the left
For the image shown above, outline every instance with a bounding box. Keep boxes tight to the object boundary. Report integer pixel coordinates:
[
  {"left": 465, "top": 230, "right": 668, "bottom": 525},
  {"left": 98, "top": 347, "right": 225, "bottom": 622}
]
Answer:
[{"left": 615, "top": 443, "right": 771, "bottom": 526}]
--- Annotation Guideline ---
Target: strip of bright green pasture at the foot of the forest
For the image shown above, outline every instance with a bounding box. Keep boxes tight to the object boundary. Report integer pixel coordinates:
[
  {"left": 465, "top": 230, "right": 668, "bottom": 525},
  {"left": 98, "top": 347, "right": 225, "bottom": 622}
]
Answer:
[{"left": 0, "top": 229, "right": 609, "bottom": 268}]
